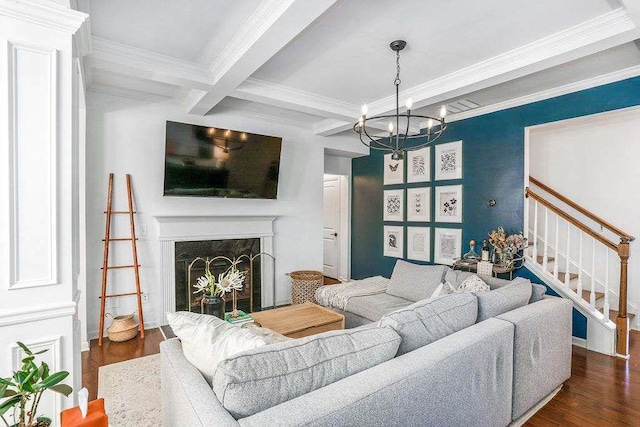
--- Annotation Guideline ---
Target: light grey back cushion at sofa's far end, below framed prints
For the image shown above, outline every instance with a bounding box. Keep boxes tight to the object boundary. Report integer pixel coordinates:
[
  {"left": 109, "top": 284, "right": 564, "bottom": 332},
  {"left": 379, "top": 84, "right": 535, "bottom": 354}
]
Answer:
[{"left": 387, "top": 259, "right": 449, "bottom": 301}]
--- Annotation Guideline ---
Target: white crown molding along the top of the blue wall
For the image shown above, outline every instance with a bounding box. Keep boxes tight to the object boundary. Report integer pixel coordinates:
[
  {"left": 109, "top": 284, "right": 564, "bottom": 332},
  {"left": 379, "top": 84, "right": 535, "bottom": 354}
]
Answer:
[{"left": 436, "top": 65, "right": 640, "bottom": 125}]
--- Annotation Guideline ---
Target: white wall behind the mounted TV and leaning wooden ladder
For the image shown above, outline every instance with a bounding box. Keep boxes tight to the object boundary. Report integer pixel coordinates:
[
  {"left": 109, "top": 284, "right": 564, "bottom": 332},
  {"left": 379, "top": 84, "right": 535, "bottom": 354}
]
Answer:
[{"left": 86, "top": 93, "right": 357, "bottom": 337}]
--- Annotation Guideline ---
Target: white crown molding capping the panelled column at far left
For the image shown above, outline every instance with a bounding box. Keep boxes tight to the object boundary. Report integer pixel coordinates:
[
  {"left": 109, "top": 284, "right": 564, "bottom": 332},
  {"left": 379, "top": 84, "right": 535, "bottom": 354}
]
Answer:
[{"left": 0, "top": 0, "right": 89, "bottom": 34}]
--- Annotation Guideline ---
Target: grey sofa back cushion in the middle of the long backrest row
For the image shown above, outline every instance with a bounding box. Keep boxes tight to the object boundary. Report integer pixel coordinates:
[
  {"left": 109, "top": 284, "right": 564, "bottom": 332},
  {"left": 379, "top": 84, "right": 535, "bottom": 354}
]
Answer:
[{"left": 378, "top": 293, "right": 478, "bottom": 356}]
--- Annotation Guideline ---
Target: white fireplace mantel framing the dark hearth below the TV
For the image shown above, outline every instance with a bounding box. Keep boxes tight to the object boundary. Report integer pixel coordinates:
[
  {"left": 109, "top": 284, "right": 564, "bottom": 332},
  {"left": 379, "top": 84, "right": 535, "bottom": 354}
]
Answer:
[{"left": 154, "top": 215, "right": 277, "bottom": 324}]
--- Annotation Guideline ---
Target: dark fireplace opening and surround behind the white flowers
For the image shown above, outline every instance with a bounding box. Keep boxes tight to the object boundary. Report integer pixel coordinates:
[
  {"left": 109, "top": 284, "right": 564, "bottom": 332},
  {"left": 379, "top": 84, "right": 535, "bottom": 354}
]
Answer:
[{"left": 175, "top": 238, "right": 264, "bottom": 313}]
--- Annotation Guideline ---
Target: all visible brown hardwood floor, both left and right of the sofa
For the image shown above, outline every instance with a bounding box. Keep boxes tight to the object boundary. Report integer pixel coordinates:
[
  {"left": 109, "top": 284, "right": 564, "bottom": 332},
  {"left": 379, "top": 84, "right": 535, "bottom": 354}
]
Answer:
[{"left": 82, "top": 329, "right": 640, "bottom": 427}]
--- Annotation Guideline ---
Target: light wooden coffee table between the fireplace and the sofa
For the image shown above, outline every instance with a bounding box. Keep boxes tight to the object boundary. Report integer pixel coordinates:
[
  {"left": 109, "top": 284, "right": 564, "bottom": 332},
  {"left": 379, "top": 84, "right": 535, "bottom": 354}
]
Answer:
[{"left": 251, "top": 302, "right": 344, "bottom": 338}]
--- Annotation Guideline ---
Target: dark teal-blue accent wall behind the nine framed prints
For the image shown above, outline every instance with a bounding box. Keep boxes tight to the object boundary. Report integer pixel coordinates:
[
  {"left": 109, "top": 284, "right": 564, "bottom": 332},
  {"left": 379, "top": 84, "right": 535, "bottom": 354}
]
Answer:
[{"left": 351, "top": 77, "right": 640, "bottom": 338}]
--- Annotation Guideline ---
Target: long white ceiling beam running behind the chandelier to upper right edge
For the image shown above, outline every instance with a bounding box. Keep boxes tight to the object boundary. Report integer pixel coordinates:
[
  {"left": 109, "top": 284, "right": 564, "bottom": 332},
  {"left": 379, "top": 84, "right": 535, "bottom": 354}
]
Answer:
[{"left": 314, "top": 7, "right": 640, "bottom": 136}]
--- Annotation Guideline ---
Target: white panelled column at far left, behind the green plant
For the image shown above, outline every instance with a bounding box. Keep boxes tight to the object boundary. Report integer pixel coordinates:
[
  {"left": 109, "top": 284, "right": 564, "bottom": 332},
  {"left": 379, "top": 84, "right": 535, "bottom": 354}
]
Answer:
[{"left": 0, "top": 0, "right": 87, "bottom": 425}]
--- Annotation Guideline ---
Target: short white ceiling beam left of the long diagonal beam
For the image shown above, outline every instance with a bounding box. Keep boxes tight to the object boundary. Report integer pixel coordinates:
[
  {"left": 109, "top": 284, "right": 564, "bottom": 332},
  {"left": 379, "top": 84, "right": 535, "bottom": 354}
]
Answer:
[{"left": 89, "top": 36, "right": 211, "bottom": 89}]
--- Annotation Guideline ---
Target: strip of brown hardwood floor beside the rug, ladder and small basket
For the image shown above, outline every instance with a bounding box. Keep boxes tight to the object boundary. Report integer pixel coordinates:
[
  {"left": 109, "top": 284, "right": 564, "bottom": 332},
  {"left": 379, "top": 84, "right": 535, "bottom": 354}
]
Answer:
[{"left": 82, "top": 328, "right": 164, "bottom": 400}]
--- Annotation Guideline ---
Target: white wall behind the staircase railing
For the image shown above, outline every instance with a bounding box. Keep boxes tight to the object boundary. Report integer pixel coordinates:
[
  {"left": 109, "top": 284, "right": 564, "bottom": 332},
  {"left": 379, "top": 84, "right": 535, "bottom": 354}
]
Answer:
[{"left": 529, "top": 108, "right": 640, "bottom": 320}]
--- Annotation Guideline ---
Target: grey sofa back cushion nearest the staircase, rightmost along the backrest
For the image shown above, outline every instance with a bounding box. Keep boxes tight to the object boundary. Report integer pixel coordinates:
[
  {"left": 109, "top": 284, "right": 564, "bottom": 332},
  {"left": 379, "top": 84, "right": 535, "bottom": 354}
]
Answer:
[{"left": 476, "top": 277, "right": 531, "bottom": 322}]
